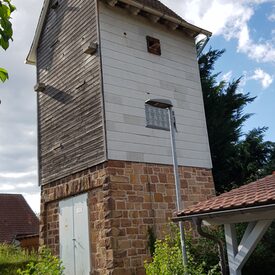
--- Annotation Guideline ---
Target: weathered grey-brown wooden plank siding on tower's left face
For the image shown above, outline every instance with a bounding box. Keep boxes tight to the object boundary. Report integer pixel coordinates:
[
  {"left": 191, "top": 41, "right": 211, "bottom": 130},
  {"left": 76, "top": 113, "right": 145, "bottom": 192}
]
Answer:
[{"left": 37, "top": 0, "right": 106, "bottom": 184}]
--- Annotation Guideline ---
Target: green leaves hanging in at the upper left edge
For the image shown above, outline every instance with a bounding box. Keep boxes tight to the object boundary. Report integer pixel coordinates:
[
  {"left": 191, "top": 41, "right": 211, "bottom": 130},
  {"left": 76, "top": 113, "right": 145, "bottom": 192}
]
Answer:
[{"left": 0, "top": 0, "right": 15, "bottom": 82}]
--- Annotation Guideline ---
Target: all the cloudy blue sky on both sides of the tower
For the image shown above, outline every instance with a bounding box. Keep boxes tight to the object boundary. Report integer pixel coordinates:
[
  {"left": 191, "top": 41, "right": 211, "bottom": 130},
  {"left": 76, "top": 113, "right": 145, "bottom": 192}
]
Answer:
[{"left": 0, "top": 0, "right": 275, "bottom": 212}]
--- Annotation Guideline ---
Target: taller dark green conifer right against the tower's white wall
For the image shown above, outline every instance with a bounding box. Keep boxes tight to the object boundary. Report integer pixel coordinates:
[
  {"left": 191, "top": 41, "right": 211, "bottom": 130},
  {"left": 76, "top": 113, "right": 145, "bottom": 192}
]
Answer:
[{"left": 199, "top": 49, "right": 254, "bottom": 192}]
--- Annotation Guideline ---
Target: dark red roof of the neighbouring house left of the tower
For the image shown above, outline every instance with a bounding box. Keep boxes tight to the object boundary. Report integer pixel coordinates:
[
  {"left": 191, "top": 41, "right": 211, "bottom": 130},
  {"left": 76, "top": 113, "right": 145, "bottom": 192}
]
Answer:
[{"left": 0, "top": 194, "right": 39, "bottom": 243}]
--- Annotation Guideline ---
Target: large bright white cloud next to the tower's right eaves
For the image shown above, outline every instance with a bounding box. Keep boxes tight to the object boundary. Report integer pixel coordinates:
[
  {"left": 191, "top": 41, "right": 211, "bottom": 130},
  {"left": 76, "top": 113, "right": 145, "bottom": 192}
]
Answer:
[{"left": 162, "top": 0, "right": 275, "bottom": 62}]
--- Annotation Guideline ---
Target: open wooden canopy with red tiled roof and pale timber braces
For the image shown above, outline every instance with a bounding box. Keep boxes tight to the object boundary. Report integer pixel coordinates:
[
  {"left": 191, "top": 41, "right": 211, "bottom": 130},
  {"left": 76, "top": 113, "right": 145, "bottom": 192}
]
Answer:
[{"left": 173, "top": 172, "right": 275, "bottom": 275}]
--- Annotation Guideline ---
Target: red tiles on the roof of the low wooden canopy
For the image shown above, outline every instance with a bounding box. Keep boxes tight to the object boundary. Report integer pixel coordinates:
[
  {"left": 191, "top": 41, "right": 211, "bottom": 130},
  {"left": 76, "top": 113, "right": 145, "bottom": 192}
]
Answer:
[{"left": 177, "top": 173, "right": 275, "bottom": 216}]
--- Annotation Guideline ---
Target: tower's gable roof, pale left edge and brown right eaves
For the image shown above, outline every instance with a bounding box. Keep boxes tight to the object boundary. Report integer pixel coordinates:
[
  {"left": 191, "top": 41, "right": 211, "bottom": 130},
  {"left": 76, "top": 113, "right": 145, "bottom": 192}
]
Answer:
[{"left": 26, "top": 0, "right": 212, "bottom": 64}]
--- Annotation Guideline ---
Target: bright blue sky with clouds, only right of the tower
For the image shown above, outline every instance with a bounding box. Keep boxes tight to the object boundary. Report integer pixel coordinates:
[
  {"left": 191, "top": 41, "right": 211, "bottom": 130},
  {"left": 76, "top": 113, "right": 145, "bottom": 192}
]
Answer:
[{"left": 162, "top": 0, "right": 275, "bottom": 141}]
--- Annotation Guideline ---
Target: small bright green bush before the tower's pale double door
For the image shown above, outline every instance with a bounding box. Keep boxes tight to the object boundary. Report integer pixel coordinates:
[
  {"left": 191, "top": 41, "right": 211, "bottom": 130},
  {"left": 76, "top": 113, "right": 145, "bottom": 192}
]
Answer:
[{"left": 17, "top": 247, "right": 64, "bottom": 275}]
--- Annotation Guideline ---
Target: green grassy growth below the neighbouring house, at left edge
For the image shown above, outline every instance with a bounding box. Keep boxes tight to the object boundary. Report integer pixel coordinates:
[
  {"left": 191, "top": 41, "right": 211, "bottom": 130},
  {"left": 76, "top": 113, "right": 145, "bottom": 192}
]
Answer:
[{"left": 0, "top": 244, "right": 38, "bottom": 275}]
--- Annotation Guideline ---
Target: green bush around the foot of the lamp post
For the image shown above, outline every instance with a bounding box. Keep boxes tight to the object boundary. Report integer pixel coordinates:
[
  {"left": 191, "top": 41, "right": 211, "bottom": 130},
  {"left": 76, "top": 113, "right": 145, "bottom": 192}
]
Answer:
[{"left": 145, "top": 225, "right": 220, "bottom": 275}]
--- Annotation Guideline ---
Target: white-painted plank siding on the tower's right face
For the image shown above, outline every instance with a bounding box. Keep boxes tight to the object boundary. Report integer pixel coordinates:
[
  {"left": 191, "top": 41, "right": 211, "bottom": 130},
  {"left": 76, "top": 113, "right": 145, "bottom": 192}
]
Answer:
[{"left": 99, "top": 3, "right": 211, "bottom": 168}]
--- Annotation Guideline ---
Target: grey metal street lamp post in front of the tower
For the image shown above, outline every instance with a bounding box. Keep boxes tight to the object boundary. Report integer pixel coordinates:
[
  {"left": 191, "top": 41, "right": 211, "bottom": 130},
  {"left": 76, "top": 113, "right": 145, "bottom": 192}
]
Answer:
[{"left": 145, "top": 99, "right": 188, "bottom": 274}]
